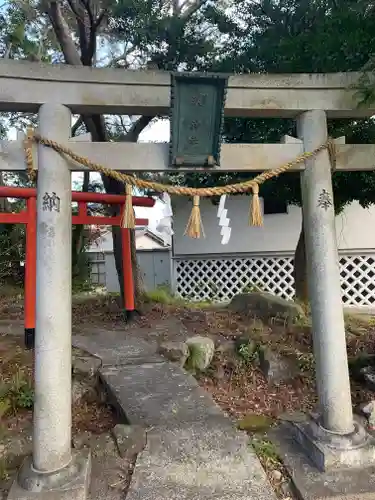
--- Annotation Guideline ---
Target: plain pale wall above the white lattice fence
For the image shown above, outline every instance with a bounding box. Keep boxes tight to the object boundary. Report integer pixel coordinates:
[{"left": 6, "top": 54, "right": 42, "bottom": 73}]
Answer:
[{"left": 173, "top": 196, "right": 375, "bottom": 256}]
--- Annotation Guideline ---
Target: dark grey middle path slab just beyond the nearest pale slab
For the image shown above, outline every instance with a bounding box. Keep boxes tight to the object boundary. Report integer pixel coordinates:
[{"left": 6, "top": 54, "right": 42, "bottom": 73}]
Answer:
[{"left": 99, "top": 362, "right": 227, "bottom": 427}]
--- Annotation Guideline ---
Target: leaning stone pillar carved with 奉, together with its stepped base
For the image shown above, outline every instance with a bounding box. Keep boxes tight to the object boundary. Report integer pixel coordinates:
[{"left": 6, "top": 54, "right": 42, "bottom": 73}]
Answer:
[{"left": 294, "top": 110, "right": 374, "bottom": 471}]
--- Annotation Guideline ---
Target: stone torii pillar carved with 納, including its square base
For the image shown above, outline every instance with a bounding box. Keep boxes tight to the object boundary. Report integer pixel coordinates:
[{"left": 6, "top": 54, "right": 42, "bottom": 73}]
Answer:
[{"left": 8, "top": 104, "right": 91, "bottom": 500}]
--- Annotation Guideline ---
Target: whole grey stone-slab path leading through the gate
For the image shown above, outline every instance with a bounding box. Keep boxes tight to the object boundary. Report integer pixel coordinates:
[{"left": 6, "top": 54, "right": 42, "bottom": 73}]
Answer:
[{"left": 73, "top": 331, "right": 276, "bottom": 500}]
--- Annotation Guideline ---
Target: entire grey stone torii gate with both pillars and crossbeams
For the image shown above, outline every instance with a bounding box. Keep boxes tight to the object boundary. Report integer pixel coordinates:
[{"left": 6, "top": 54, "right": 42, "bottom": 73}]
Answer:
[{"left": 0, "top": 61, "right": 375, "bottom": 500}]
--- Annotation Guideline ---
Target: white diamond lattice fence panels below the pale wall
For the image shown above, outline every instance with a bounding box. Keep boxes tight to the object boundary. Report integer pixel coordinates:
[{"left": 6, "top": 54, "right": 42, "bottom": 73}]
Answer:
[{"left": 174, "top": 254, "right": 375, "bottom": 307}]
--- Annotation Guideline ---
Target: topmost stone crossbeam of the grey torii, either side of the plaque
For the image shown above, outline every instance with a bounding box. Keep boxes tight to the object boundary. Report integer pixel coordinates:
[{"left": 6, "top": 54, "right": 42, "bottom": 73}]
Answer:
[{"left": 0, "top": 59, "right": 375, "bottom": 118}]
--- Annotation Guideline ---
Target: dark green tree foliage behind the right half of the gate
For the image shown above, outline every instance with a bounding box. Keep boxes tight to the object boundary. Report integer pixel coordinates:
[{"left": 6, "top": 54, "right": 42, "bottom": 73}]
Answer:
[{"left": 181, "top": 0, "right": 375, "bottom": 209}]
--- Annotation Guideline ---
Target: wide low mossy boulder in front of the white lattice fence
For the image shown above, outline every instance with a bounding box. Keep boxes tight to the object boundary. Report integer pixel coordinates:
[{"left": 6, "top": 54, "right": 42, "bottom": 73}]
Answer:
[{"left": 228, "top": 292, "right": 304, "bottom": 325}]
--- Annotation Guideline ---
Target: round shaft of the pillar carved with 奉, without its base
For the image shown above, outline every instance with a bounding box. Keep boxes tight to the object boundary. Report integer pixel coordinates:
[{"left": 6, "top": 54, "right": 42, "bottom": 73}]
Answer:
[{"left": 297, "top": 111, "right": 353, "bottom": 434}]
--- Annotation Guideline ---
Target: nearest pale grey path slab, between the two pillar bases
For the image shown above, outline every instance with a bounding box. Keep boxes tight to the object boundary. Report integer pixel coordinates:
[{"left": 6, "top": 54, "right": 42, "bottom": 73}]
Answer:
[{"left": 126, "top": 420, "right": 276, "bottom": 500}]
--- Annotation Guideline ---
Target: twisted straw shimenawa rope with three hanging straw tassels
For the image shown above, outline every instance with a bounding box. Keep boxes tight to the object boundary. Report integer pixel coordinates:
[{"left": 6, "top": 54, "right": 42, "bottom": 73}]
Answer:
[{"left": 24, "top": 129, "right": 335, "bottom": 238}]
